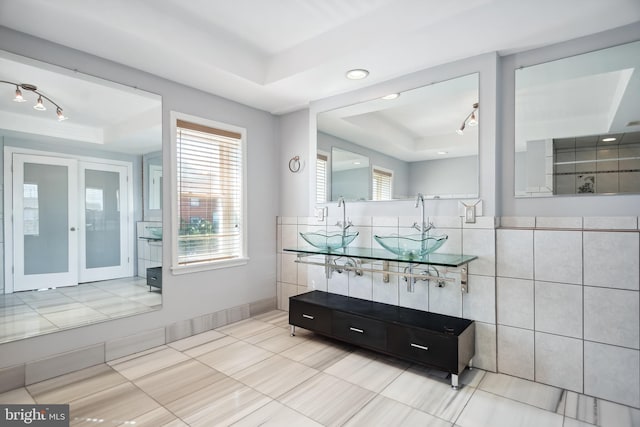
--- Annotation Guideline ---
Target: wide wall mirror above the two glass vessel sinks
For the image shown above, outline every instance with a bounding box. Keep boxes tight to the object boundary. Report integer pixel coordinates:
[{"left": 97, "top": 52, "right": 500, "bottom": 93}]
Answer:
[{"left": 316, "top": 73, "right": 480, "bottom": 203}]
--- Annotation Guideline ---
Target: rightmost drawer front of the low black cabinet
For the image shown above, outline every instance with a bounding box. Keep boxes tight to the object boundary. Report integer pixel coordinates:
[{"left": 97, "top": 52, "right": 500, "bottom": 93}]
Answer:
[{"left": 387, "top": 325, "right": 458, "bottom": 372}]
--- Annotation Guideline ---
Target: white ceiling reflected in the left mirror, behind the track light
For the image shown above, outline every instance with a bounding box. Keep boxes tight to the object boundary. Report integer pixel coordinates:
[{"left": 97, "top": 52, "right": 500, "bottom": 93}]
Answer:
[{"left": 0, "top": 52, "right": 162, "bottom": 154}]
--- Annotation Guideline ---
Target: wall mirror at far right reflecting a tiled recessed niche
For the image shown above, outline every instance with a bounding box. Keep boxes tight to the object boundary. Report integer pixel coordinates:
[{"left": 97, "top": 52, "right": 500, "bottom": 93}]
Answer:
[{"left": 515, "top": 41, "right": 640, "bottom": 197}]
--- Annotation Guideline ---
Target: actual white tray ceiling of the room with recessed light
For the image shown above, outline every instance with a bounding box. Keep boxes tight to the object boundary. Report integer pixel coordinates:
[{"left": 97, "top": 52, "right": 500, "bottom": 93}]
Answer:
[{"left": 0, "top": 0, "right": 640, "bottom": 114}]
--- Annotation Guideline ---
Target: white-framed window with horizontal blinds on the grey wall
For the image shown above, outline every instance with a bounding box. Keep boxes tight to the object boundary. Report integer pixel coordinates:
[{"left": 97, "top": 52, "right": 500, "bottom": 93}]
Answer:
[{"left": 172, "top": 113, "right": 246, "bottom": 270}]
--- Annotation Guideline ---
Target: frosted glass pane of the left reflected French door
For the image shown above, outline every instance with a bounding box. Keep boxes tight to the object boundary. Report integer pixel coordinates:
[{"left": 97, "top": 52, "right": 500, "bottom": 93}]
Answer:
[{"left": 23, "top": 163, "right": 69, "bottom": 275}]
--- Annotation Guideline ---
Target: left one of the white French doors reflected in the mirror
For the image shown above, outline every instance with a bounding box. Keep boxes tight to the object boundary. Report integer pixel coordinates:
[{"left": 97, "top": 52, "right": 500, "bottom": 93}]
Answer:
[{"left": 12, "top": 153, "right": 78, "bottom": 291}]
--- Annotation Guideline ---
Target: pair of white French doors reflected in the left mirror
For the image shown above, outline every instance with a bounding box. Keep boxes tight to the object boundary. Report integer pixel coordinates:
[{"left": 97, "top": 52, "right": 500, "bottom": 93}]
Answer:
[{"left": 12, "top": 153, "right": 133, "bottom": 291}]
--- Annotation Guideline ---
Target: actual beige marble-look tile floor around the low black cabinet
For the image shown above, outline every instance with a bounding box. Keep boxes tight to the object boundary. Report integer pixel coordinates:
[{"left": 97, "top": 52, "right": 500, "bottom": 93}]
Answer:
[{"left": 0, "top": 311, "right": 640, "bottom": 427}]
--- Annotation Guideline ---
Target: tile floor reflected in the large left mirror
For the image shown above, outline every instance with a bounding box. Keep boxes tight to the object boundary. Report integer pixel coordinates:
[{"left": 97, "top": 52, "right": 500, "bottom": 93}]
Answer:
[{"left": 0, "top": 277, "right": 162, "bottom": 343}]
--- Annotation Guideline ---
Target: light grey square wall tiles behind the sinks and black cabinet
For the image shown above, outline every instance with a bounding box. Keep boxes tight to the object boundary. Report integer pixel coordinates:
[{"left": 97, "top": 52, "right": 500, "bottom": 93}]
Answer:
[{"left": 277, "top": 216, "right": 640, "bottom": 408}]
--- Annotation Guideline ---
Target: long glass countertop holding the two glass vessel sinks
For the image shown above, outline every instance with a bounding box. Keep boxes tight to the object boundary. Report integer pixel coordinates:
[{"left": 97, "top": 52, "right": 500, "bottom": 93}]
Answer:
[{"left": 283, "top": 246, "right": 478, "bottom": 267}]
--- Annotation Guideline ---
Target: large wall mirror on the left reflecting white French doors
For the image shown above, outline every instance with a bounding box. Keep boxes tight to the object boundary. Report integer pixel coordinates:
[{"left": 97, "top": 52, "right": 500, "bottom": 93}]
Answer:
[{"left": 0, "top": 52, "right": 162, "bottom": 343}]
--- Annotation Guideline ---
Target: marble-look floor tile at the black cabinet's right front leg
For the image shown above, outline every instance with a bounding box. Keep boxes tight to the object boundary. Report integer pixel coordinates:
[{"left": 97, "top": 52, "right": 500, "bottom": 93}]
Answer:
[{"left": 380, "top": 367, "right": 475, "bottom": 421}]
